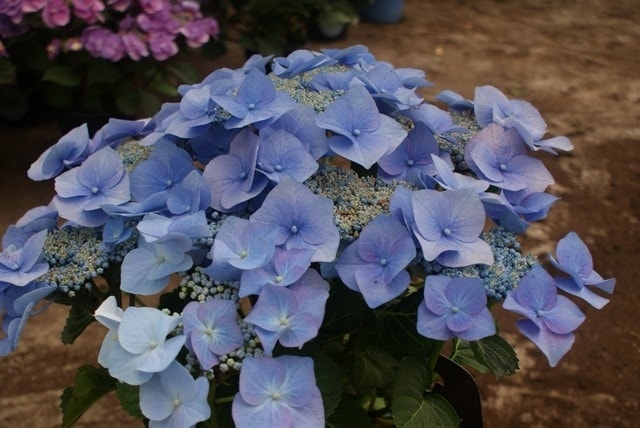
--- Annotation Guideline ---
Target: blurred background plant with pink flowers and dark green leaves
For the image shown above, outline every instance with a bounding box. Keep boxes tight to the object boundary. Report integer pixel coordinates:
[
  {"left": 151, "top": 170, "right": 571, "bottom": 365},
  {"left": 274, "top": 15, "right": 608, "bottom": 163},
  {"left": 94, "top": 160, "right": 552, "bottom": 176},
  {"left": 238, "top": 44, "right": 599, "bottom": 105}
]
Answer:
[{"left": 0, "top": 0, "right": 221, "bottom": 122}]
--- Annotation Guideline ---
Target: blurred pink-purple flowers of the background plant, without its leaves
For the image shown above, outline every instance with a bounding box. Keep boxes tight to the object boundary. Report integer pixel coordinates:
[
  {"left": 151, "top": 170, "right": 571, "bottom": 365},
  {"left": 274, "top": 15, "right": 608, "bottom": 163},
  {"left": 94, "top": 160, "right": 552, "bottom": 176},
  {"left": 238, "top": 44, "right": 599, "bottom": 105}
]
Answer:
[{"left": 0, "top": 0, "right": 219, "bottom": 62}]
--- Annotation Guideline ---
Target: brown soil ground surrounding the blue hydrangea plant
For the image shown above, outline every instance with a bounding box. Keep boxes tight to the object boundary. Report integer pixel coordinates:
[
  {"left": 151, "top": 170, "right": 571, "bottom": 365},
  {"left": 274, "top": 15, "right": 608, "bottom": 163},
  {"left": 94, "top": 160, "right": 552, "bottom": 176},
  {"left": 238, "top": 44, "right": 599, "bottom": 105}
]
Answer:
[{"left": 0, "top": 0, "right": 640, "bottom": 428}]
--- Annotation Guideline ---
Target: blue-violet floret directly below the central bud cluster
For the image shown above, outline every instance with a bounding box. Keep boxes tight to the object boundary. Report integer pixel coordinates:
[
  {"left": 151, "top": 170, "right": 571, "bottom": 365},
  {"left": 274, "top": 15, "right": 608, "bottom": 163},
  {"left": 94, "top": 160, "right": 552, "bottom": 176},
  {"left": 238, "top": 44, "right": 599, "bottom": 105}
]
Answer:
[{"left": 335, "top": 215, "right": 416, "bottom": 308}]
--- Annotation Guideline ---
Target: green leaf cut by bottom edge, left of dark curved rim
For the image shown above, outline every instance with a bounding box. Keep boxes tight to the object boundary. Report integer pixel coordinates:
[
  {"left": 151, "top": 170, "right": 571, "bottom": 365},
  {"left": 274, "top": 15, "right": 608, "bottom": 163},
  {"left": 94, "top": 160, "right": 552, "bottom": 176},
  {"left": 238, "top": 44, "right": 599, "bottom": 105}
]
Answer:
[{"left": 392, "top": 394, "right": 459, "bottom": 428}]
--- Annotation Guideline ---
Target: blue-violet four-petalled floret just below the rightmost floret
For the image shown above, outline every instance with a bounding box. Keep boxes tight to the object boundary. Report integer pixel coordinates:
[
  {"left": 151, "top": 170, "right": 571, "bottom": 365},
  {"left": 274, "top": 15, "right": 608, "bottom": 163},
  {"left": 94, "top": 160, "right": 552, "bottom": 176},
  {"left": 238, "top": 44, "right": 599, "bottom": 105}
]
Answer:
[{"left": 502, "top": 265, "right": 585, "bottom": 367}]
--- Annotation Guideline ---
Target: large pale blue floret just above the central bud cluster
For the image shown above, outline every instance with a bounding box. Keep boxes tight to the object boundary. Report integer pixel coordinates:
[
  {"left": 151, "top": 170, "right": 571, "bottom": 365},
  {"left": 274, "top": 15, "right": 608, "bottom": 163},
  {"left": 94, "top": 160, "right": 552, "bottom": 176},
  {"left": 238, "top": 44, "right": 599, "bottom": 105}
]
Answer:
[{"left": 316, "top": 85, "right": 407, "bottom": 168}]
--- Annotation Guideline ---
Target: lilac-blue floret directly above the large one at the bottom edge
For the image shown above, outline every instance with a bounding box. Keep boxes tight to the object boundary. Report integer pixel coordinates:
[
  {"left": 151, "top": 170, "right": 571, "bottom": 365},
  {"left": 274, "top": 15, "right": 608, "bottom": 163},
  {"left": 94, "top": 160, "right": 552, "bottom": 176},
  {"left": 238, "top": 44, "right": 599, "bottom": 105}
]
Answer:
[{"left": 245, "top": 276, "right": 329, "bottom": 354}]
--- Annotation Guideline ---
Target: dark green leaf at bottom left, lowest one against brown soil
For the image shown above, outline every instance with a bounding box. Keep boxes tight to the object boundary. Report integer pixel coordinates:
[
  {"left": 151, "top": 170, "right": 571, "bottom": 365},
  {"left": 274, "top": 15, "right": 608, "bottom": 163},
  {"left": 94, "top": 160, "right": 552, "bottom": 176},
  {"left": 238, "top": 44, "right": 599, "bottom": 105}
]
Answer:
[{"left": 60, "top": 365, "right": 116, "bottom": 428}]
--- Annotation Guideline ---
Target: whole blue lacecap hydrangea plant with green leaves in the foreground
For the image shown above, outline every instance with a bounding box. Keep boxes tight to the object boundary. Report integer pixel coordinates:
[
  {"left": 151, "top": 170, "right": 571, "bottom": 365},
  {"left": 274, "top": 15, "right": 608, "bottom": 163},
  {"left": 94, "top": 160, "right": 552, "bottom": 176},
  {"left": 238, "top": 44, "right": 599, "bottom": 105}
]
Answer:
[{"left": 0, "top": 46, "right": 615, "bottom": 428}]
